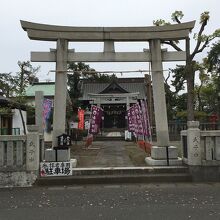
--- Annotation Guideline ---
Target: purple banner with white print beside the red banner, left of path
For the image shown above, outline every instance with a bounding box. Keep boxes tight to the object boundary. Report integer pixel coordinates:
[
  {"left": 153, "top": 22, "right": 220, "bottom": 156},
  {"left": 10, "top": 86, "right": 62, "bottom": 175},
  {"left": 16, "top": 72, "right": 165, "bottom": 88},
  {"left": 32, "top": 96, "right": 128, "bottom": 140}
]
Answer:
[{"left": 89, "top": 105, "right": 103, "bottom": 134}]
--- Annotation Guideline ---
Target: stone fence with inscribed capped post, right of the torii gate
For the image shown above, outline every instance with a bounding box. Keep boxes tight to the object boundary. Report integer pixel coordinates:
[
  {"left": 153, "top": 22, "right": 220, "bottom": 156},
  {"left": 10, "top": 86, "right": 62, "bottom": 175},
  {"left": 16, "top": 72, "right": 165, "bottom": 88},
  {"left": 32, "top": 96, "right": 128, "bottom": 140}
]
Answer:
[{"left": 181, "top": 121, "right": 220, "bottom": 182}]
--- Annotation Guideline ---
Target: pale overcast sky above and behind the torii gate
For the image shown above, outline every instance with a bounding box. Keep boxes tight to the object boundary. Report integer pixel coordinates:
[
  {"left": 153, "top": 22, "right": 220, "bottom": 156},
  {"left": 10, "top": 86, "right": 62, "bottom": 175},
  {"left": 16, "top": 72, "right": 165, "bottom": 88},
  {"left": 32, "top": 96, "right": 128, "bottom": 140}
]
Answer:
[{"left": 0, "top": 0, "right": 220, "bottom": 81}]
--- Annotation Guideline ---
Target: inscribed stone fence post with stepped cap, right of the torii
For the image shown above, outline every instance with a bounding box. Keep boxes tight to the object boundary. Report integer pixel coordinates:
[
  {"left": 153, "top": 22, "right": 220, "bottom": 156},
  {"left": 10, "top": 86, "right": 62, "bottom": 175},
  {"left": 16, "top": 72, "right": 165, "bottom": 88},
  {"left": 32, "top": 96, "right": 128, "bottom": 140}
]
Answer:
[{"left": 187, "top": 121, "right": 202, "bottom": 165}]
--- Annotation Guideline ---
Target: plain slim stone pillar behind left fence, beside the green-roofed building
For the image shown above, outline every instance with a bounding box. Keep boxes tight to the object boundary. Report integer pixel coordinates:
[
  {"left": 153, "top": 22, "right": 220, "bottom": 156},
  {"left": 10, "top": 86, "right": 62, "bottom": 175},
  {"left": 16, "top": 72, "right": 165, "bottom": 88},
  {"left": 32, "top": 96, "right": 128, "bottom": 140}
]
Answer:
[{"left": 35, "top": 91, "right": 44, "bottom": 133}]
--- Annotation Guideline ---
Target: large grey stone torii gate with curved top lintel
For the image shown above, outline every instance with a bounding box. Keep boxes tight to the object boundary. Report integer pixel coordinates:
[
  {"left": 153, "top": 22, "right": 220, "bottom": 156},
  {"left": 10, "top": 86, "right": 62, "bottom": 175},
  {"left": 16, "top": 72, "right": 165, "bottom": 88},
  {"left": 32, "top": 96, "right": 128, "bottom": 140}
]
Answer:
[{"left": 21, "top": 21, "right": 195, "bottom": 146}]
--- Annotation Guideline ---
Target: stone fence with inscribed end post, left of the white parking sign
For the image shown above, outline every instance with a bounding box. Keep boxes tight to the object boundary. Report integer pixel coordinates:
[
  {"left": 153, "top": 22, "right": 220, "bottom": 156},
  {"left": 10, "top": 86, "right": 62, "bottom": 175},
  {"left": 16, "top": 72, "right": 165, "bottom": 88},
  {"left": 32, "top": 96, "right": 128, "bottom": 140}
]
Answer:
[{"left": 0, "top": 132, "right": 43, "bottom": 187}]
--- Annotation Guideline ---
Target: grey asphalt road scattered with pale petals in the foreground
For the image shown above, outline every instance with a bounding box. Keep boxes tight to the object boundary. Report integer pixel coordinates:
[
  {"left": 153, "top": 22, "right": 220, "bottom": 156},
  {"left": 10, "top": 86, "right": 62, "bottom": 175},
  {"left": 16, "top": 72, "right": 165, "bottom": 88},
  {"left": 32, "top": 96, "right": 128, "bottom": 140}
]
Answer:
[{"left": 0, "top": 183, "right": 220, "bottom": 220}]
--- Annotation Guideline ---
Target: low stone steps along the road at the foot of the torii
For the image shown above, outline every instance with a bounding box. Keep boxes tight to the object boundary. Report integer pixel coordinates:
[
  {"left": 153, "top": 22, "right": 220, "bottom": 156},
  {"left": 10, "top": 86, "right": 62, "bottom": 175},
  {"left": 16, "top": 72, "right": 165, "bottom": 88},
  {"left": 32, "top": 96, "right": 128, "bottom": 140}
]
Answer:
[{"left": 35, "top": 166, "right": 192, "bottom": 186}]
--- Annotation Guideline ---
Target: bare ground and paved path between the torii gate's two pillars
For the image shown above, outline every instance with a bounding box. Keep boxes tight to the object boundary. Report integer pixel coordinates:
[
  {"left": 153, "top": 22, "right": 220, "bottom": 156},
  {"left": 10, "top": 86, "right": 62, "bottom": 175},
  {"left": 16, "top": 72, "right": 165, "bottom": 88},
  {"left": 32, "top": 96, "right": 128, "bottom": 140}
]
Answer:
[{"left": 71, "top": 138, "right": 181, "bottom": 168}]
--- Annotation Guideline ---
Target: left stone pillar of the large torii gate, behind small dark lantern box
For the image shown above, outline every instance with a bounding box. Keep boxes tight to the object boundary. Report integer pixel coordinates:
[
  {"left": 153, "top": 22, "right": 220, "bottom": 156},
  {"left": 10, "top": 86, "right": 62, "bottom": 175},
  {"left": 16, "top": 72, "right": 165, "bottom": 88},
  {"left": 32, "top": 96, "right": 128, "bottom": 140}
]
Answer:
[{"left": 52, "top": 39, "right": 68, "bottom": 147}]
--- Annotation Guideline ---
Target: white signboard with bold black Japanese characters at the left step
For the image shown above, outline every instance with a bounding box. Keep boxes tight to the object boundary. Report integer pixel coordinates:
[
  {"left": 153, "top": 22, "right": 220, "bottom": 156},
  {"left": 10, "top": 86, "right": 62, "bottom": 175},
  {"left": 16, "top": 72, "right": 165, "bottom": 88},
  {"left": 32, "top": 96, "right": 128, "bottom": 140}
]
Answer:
[{"left": 40, "top": 162, "right": 72, "bottom": 177}]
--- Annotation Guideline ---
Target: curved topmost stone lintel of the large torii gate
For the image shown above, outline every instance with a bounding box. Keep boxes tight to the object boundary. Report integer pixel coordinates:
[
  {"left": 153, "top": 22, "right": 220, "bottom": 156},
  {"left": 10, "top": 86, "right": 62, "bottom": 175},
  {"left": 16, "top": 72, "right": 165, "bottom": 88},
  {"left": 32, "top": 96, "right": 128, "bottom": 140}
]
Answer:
[{"left": 20, "top": 20, "right": 195, "bottom": 42}]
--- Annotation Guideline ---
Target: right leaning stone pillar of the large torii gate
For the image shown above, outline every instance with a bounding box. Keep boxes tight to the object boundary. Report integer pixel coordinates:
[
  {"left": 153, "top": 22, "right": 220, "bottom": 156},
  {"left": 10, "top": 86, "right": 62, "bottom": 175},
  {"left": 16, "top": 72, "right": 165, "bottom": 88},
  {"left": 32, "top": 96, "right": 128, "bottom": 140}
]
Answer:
[{"left": 150, "top": 40, "right": 169, "bottom": 146}]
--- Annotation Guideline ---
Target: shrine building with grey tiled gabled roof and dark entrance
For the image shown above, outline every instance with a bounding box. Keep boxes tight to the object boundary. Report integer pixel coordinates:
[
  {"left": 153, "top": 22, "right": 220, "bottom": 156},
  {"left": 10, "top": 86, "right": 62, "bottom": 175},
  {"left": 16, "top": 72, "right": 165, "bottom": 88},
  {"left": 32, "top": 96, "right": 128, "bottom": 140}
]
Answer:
[{"left": 80, "top": 77, "right": 147, "bottom": 130}]
